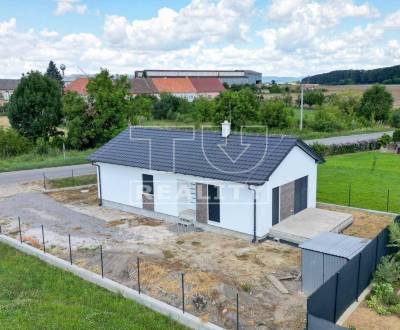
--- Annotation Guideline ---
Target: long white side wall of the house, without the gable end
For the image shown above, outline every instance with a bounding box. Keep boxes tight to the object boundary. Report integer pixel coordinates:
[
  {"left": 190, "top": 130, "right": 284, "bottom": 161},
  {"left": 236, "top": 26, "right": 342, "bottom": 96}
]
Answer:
[{"left": 98, "top": 163, "right": 253, "bottom": 235}]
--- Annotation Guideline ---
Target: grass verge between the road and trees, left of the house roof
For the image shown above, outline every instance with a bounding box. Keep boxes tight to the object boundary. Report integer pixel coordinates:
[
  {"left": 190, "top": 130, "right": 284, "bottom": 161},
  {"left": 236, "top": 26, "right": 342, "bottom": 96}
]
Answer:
[{"left": 0, "top": 149, "right": 94, "bottom": 172}]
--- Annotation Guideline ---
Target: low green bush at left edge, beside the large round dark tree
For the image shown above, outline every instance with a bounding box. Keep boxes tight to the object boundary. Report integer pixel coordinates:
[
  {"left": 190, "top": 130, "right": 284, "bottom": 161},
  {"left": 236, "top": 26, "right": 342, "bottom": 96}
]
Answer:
[{"left": 0, "top": 127, "right": 32, "bottom": 158}]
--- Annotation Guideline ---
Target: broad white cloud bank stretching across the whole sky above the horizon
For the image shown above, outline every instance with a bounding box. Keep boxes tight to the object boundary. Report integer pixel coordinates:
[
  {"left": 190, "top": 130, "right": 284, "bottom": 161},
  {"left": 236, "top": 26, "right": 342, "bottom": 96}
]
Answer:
[{"left": 0, "top": 0, "right": 400, "bottom": 77}]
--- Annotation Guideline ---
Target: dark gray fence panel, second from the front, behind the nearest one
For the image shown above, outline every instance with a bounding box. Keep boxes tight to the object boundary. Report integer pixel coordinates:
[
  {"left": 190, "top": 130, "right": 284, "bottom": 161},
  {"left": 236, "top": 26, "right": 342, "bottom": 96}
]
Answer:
[{"left": 335, "top": 255, "right": 361, "bottom": 321}]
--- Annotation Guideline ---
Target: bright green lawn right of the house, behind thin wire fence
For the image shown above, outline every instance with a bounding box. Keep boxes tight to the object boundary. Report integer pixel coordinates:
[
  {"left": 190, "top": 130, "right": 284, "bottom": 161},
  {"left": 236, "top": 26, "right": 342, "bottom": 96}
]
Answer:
[{"left": 318, "top": 152, "right": 400, "bottom": 213}]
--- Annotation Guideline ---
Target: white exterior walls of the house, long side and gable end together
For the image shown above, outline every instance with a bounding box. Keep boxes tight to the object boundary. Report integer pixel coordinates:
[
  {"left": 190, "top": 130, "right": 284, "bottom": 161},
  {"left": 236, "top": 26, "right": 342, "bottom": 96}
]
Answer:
[{"left": 99, "top": 147, "right": 317, "bottom": 237}]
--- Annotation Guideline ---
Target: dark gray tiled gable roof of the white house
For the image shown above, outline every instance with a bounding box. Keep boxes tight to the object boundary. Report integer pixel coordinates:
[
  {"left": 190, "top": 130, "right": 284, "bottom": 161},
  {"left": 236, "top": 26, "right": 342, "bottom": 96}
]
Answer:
[{"left": 88, "top": 127, "right": 323, "bottom": 185}]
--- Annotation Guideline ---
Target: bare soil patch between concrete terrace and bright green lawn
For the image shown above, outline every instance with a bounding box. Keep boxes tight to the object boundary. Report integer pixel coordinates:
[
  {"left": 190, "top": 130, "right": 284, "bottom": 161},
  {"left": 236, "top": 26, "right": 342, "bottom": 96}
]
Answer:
[{"left": 321, "top": 206, "right": 393, "bottom": 238}]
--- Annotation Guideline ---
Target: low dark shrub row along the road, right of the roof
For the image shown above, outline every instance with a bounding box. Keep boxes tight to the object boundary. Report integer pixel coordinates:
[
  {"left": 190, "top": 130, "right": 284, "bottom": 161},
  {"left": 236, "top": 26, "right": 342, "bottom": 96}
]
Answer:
[{"left": 311, "top": 140, "right": 381, "bottom": 156}]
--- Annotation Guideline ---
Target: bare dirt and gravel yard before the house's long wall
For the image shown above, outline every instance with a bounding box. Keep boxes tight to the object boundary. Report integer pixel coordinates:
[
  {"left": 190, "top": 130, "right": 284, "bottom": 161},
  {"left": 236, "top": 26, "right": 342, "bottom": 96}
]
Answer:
[{"left": 0, "top": 187, "right": 306, "bottom": 329}]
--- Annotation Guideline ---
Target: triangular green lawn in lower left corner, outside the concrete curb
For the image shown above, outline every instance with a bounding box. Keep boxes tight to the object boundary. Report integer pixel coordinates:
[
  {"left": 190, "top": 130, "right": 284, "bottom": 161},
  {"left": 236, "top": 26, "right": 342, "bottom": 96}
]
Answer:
[{"left": 0, "top": 244, "right": 186, "bottom": 330}]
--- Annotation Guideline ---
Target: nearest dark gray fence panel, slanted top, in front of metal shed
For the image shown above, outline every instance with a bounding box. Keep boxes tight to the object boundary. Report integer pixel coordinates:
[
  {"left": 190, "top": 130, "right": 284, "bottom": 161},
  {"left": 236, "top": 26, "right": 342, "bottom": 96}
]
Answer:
[{"left": 307, "top": 276, "right": 336, "bottom": 322}]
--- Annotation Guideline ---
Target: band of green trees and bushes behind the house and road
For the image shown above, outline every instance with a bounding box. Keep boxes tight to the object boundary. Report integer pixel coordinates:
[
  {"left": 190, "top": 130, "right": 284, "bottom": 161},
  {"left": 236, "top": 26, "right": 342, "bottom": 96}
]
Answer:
[{"left": 0, "top": 62, "right": 400, "bottom": 156}]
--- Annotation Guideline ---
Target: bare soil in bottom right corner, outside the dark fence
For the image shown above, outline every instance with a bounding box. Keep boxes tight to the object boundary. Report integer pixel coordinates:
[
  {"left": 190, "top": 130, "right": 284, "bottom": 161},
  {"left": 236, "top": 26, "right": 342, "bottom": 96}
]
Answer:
[{"left": 345, "top": 303, "right": 400, "bottom": 330}]
